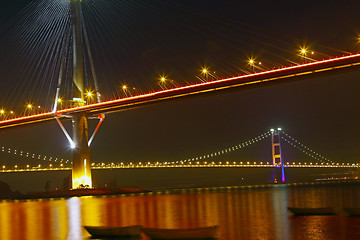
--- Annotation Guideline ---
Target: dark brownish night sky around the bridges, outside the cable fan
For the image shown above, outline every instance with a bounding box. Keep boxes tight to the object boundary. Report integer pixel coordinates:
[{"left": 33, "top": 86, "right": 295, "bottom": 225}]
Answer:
[{"left": 0, "top": 0, "right": 360, "bottom": 191}]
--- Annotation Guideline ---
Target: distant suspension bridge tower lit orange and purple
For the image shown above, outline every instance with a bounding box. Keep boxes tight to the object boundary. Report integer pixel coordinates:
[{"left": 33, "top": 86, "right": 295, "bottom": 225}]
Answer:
[{"left": 270, "top": 128, "right": 285, "bottom": 183}]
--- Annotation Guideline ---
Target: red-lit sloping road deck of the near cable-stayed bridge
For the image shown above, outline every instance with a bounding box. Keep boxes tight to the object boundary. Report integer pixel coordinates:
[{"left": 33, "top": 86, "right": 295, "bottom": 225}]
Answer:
[{"left": 0, "top": 53, "right": 360, "bottom": 128}]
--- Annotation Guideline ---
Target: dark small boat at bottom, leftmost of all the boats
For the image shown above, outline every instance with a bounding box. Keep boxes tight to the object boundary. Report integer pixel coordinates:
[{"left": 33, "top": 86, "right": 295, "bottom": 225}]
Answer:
[{"left": 84, "top": 225, "right": 142, "bottom": 238}]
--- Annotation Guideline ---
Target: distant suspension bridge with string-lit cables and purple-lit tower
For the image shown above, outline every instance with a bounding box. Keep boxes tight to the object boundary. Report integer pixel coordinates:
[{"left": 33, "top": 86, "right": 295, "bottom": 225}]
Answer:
[{"left": 0, "top": 128, "right": 360, "bottom": 183}]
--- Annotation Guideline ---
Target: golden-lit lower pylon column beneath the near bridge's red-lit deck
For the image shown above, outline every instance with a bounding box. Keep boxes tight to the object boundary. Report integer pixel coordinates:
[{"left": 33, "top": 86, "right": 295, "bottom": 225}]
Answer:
[{"left": 72, "top": 113, "right": 92, "bottom": 188}]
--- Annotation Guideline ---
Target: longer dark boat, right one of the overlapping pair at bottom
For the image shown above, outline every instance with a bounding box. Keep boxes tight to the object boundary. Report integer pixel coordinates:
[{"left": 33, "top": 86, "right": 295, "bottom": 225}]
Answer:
[{"left": 143, "top": 226, "right": 218, "bottom": 239}]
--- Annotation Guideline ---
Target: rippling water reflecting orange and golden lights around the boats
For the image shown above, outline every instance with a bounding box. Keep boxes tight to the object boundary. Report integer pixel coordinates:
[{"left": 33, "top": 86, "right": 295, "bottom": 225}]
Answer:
[{"left": 0, "top": 184, "right": 360, "bottom": 240}]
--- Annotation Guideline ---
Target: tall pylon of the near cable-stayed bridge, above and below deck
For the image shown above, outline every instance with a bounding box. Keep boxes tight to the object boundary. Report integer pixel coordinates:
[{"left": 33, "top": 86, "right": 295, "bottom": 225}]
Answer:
[{"left": 70, "top": 0, "right": 92, "bottom": 188}]
